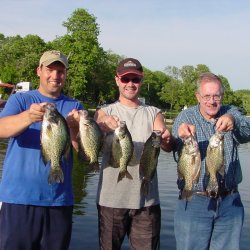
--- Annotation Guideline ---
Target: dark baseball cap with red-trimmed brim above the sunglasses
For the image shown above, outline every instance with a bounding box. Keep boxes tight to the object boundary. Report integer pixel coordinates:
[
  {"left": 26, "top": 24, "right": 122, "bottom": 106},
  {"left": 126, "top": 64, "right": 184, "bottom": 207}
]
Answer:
[{"left": 116, "top": 58, "right": 143, "bottom": 76}]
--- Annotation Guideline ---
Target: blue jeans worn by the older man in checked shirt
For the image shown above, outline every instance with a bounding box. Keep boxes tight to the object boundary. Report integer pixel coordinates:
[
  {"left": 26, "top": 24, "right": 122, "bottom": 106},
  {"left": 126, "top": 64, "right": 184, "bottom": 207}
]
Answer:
[{"left": 174, "top": 192, "right": 244, "bottom": 250}]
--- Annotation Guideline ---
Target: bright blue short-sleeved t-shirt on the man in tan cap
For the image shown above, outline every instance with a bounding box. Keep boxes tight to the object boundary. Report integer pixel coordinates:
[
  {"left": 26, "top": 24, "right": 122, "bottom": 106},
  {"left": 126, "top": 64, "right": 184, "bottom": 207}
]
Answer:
[{"left": 0, "top": 90, "right": 83, "bottom": 206}]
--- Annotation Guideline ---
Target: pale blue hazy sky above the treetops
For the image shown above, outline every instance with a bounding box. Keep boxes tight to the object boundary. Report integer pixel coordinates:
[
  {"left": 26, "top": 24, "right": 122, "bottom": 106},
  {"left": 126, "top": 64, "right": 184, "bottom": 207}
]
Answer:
[{"left": 0, "top": 0, "right": 250, "bottom": 90}]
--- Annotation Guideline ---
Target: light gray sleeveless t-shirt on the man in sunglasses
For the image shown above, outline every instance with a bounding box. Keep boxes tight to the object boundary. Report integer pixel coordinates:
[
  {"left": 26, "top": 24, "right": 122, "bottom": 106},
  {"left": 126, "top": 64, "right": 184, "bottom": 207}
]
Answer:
[{"left": 97, "top": 102, "right": 160, "bottom": 209}]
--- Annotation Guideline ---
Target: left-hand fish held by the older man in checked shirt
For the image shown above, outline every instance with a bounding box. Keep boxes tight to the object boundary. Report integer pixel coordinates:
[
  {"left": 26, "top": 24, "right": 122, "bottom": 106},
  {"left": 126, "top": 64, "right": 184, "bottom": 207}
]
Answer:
[{"left": 177, "top": 135, "right": 201, "bottom": 200}]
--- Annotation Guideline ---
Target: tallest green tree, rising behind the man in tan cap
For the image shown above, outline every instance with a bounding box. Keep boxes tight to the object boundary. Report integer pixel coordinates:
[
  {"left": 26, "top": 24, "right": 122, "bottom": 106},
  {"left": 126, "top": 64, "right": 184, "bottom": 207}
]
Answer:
[{"left": 52, "top": 9, "right": 106, "bottom": 102}]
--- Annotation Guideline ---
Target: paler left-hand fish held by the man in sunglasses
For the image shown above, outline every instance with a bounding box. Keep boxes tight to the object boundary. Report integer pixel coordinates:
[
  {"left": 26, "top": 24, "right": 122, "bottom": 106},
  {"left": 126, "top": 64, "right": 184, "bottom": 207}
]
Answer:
[{"left": 111, "top": 121, "right": 134, "bottom": 182}]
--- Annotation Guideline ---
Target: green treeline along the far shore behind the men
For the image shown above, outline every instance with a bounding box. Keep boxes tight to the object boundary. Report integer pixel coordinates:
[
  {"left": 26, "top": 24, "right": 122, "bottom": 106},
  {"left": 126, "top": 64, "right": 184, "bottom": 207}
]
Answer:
[{"left": 0, "top": 9, "right": 250, "bottom": 114}]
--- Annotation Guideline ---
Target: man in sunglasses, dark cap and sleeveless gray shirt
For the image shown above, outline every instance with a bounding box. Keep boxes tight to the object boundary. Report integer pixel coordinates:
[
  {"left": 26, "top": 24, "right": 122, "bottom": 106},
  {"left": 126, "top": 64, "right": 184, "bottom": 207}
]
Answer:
[{"left": 95, "top": 58, "right": 172, "bottom": 250}]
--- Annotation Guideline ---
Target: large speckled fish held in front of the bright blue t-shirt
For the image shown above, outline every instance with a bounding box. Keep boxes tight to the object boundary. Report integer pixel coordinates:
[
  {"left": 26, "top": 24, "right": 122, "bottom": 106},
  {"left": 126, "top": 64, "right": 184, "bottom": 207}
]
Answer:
[{"left": 40, "top": 103, "right": 71, "bottom": 184}]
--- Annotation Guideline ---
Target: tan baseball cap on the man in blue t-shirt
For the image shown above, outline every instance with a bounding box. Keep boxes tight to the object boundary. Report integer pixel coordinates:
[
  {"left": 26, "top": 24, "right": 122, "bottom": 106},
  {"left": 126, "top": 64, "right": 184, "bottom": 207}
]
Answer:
[{"left": 39, "top": 50, "right": 69, "bottom": 68}]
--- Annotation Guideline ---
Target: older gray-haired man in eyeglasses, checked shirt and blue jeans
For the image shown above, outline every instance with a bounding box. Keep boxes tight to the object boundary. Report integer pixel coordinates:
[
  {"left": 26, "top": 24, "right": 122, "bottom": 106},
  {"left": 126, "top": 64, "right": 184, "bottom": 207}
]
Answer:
[{"left": 172, "top": 73, "right": 250, "bottom": 250}]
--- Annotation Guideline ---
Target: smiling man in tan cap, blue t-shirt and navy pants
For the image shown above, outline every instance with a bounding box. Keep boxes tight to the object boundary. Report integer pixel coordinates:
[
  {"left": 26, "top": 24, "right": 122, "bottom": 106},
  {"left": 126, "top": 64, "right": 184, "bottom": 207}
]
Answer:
[{"left": 0, "top": 50, "right": 83, "bottom": 250}]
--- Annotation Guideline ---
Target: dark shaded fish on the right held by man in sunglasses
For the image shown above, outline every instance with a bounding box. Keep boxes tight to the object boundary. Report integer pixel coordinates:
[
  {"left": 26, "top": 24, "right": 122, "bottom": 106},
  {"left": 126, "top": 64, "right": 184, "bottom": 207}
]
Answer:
[{"left": 139, "top": 130, "right": 161, "bottom": 196}]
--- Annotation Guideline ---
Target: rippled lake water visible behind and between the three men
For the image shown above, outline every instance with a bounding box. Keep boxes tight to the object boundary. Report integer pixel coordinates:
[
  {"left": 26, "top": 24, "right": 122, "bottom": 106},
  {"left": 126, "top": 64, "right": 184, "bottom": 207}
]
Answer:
[{"left": 0, "top": 140, "right": 250, "bottom": 250}]
